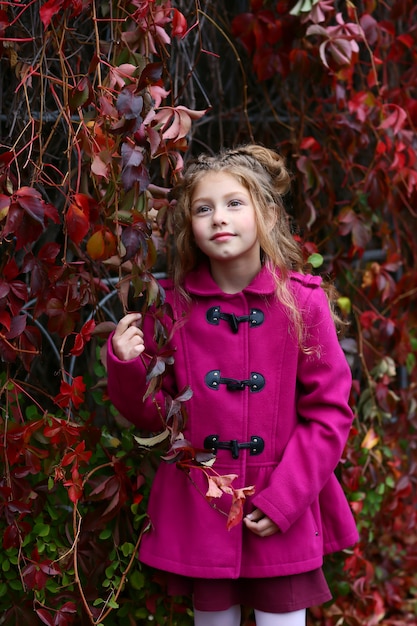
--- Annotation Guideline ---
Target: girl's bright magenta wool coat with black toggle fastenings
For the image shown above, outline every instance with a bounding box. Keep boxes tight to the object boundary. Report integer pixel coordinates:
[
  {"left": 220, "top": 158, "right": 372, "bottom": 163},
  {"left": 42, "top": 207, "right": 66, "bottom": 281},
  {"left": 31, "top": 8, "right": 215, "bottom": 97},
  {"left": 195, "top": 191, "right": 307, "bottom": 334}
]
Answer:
[{"left": 108, "top": 266, "right": 358, "bottom": 578}]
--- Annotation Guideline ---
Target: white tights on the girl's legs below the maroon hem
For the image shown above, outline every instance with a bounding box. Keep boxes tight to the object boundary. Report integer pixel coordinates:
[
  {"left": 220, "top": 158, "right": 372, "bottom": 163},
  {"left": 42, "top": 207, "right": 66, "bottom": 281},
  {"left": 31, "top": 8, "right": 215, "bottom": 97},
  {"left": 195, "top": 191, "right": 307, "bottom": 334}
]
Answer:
[{"left": 194, "top": 605, "right": 306, "bottom": 626}]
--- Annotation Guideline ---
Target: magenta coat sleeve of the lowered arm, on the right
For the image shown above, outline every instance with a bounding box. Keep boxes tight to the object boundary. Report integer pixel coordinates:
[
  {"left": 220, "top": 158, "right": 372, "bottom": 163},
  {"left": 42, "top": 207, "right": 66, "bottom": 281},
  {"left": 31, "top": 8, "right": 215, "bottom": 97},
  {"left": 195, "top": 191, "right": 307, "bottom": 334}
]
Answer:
[{"left": 253, "top": 287, "right": 353, "bottom": 532}]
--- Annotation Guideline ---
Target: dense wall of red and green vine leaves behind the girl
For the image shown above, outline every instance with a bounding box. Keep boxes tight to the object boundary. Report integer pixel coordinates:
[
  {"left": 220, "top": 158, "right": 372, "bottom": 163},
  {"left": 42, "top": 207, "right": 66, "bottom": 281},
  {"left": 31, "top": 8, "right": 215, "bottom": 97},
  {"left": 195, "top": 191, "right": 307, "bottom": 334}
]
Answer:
[{"left": 0, "top": 0, "right": 417, "bottom": 626}]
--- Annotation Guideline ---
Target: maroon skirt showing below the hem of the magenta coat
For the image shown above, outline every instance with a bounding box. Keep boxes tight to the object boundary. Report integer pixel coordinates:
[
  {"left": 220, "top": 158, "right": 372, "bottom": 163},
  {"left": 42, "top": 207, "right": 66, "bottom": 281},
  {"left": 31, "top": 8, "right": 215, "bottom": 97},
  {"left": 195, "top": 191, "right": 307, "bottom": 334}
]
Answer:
[{"left": 167, "top": 568, "right": 332, "bottom": 613}]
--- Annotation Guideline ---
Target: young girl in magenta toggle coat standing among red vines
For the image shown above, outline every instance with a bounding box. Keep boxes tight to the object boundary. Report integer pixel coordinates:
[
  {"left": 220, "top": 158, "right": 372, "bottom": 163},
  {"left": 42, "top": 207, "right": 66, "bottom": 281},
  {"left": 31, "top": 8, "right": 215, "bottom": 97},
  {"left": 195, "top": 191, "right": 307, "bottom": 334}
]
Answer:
[{"left": 108, "top": 145, "right": 357, "bottom": 626}]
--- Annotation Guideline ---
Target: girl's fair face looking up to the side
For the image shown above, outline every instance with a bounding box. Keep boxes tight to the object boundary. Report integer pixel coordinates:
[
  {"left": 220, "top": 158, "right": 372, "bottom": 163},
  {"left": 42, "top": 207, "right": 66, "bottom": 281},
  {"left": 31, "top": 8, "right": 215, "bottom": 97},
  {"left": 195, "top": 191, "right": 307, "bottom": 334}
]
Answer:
[{"left": 191, "top": 172, "right": 260, "bottom": 272}]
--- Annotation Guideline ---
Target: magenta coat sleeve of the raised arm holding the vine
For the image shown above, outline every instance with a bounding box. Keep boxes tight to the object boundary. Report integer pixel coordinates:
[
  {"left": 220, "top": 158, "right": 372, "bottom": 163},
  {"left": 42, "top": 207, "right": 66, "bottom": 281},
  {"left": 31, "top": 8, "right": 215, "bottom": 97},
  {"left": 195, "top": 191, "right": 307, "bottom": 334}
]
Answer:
[{"left": 107, "top": 312, "right": 176, "bottom": 432}]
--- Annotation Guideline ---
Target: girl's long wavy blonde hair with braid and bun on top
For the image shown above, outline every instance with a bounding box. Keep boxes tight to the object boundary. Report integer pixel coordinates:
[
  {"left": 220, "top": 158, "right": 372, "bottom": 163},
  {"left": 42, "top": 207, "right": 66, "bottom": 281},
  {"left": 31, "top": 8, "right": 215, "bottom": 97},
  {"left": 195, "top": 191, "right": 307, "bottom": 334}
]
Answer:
[{"left": 172, "top": 144, "right": 303, "bottom": 344}]
